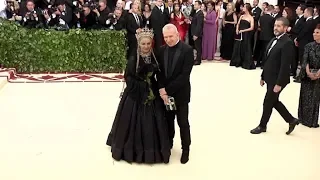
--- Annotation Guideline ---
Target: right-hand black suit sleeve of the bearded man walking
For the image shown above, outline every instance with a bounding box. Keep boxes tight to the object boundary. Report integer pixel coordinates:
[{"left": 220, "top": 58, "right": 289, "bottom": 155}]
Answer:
[{"left": 276, "top": 40, "right": 294, "bottom": 87}]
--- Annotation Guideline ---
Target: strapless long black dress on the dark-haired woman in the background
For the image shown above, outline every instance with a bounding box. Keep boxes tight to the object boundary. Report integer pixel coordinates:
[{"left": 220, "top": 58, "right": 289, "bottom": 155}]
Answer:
[{"left": 230, "top": 19, "right": 256, "bottom": 70}]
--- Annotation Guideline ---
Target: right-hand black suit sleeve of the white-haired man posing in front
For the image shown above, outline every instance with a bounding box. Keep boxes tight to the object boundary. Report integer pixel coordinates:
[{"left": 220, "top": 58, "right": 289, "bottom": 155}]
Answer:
[{"left": 165, "top": 47, "right": 194, "bottom": 96}]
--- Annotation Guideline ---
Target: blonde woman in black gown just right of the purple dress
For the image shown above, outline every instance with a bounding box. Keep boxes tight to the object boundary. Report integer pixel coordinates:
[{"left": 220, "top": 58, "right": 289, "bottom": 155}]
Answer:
[{"left": 220, "top": 3, "right": 237, "bottom": 60}]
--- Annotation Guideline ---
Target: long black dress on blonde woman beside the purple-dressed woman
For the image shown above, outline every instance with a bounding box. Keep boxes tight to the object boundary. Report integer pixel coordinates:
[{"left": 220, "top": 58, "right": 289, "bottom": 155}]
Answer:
[{"left": 220, "top": 12, "right": 235, "bottom": 60}]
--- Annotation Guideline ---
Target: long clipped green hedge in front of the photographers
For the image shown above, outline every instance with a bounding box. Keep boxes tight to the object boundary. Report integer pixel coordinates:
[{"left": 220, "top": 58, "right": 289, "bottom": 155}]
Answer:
[{"left": 0, "top": 18, "right": 127, "bottom": 73}]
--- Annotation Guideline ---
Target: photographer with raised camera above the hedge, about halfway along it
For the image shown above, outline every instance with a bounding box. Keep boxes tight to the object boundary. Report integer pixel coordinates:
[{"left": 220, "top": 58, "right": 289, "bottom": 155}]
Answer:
[{"left": 43, "top": 0, "right": 72, "bottom": 29}]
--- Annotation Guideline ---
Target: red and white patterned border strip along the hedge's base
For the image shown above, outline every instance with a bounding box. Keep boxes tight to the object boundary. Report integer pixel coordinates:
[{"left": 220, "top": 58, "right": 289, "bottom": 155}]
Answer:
[{"left": 0, "top": 68, "right": 123, "bottom": 83}]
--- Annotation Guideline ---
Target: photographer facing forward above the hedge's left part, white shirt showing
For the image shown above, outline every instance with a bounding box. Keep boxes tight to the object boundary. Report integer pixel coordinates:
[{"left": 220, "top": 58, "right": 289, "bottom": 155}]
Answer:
[{"left": 22, "top": 0, "right": 44, "bottom": 28}]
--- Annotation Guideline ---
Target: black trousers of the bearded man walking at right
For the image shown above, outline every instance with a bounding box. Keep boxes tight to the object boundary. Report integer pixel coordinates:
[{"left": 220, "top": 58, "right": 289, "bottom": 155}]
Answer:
[{"left": 259, "top": 84, "right": 294, "bottom": 128}]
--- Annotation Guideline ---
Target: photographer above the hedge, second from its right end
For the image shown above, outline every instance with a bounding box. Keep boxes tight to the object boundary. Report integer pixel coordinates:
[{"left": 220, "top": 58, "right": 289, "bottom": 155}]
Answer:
[{"left": 92, "top": 0, "right": 111, "bottom": 29}]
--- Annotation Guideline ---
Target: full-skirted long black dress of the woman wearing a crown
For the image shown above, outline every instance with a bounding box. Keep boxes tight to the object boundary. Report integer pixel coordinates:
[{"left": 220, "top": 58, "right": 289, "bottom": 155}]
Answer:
[{"left": 107, "top": 53, "right": 170, "bottom": 163}]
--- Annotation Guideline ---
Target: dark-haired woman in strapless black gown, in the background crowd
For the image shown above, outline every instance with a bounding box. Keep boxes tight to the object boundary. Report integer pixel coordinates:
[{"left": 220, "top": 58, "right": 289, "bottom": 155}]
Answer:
[{"left": 230, "top": 3, "right": 256, "bottom": 70}]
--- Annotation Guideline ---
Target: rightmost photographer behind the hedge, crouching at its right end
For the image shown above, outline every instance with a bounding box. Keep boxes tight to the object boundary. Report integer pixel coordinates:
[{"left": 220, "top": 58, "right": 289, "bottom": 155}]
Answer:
[{"left": 106, "top": 8, "right": 126, "bottom": 31}]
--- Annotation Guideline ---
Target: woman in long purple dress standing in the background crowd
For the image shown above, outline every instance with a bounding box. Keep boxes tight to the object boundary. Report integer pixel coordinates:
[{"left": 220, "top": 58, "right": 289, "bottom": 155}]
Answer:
[{"left": 202, "top": 1, "right": 217, "bottom": 60}]
